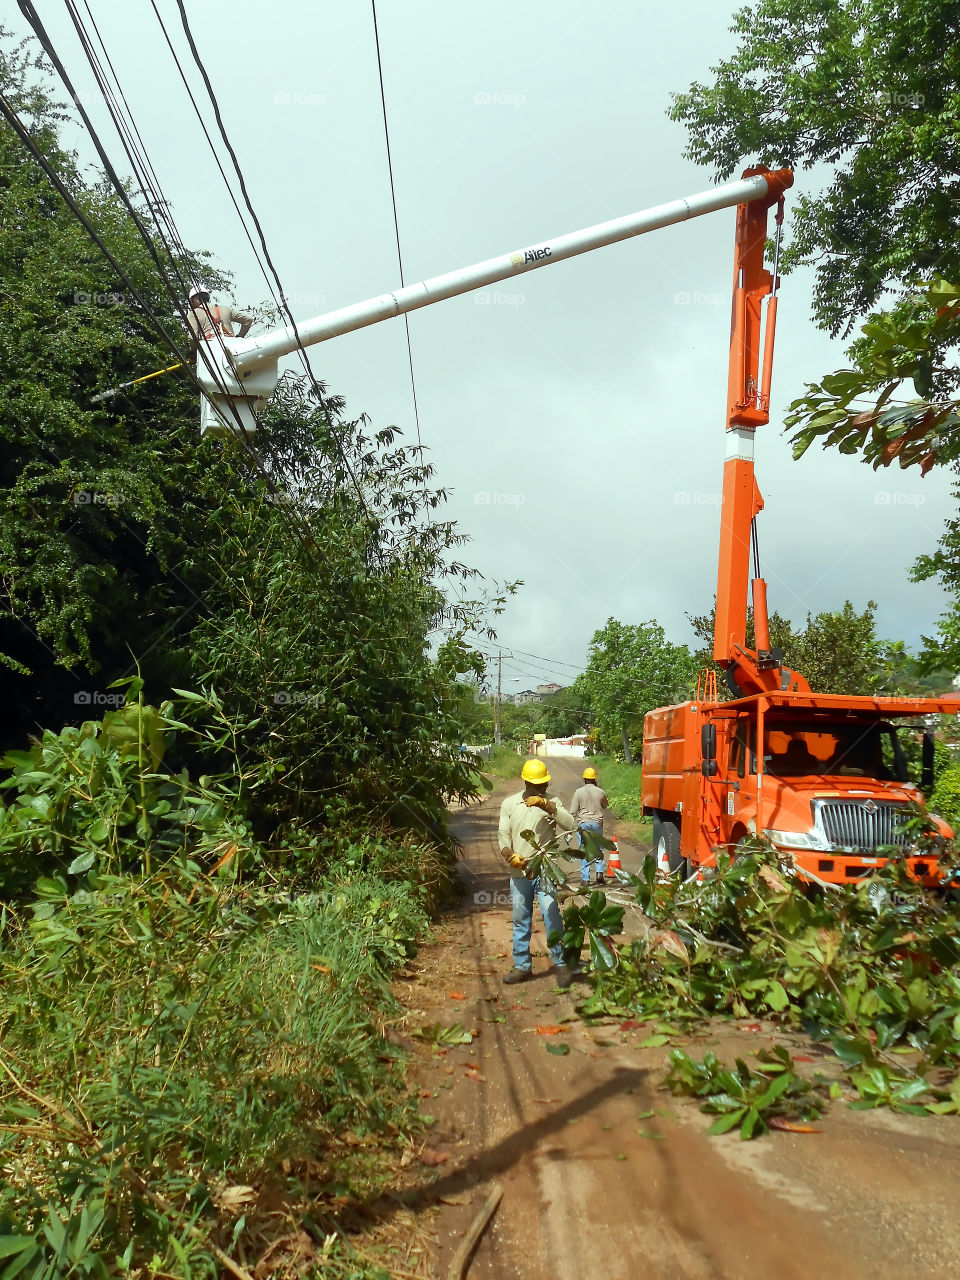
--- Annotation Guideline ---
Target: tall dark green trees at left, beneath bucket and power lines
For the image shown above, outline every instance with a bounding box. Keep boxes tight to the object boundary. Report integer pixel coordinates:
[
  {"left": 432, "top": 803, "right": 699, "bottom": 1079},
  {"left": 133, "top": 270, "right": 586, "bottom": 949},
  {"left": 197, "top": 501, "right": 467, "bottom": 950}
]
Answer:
[{"left": 0, "top": 42, "right": 491, "bottom": 838}]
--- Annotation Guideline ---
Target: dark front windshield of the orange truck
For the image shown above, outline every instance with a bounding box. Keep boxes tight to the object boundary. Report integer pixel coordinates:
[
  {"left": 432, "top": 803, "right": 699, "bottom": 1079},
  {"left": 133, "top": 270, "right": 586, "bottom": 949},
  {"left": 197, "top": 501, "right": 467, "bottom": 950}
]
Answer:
[{"left": 763, "top": 721, "right": 906, "bottom": 782}]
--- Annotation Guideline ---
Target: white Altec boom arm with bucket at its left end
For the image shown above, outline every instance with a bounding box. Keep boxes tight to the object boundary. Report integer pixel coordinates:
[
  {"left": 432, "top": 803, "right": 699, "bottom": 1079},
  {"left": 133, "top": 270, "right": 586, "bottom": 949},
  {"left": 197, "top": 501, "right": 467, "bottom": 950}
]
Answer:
[{"left": 197, "top": 174, "right": 783, "bottom": 434}]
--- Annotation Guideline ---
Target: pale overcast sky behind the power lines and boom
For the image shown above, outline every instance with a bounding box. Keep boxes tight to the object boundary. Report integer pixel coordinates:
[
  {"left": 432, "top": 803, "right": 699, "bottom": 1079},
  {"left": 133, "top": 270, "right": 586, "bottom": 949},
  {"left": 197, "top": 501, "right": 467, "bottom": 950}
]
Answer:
[{"left": 5, "top": 0, "right": 956, "bottom": 692}]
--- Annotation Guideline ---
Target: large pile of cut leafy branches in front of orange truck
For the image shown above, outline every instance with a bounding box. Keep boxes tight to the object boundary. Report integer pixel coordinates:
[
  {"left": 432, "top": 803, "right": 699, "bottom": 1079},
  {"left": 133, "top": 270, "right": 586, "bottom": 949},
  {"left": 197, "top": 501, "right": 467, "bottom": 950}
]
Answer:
[{"left": 581, "top": 841, "right": 960, "bottom": 1129}]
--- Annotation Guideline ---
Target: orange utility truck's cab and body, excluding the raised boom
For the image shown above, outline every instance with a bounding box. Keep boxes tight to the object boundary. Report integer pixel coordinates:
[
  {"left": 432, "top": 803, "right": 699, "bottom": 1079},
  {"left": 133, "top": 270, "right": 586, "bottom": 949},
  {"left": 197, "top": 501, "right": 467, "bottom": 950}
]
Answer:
[{"left": 643, "top": 692, "right": 960, "bottom": 886}]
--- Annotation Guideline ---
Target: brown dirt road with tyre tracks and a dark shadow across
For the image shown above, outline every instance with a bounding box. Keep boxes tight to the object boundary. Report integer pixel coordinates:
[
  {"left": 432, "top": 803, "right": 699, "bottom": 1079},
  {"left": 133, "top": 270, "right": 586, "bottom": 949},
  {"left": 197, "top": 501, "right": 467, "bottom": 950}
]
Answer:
[{"left": 403, "top": 760, "right": 960, "bottom": 1280}]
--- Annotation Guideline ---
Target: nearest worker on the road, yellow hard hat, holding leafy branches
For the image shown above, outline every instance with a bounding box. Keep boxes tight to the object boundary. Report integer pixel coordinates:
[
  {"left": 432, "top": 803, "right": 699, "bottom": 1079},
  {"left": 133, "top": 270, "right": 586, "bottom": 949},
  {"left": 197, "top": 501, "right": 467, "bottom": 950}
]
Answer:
[{"left": 499, "top": 760, "right": 575, "bottom": 987}]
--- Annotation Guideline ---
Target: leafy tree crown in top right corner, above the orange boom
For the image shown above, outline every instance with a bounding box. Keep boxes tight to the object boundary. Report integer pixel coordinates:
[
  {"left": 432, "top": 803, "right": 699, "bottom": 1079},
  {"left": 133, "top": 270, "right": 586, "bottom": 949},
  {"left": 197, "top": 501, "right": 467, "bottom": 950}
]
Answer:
[{"left": 671, "top": 0, "right": 960, "bottom": 337}]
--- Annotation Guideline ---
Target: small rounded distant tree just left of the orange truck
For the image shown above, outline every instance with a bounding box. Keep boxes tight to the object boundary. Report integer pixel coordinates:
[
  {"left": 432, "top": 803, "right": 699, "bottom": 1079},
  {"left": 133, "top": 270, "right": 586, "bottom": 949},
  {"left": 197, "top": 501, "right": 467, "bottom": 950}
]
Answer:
[{"left": 573, "top": 618, "right": 695, "bottom": 756}]
